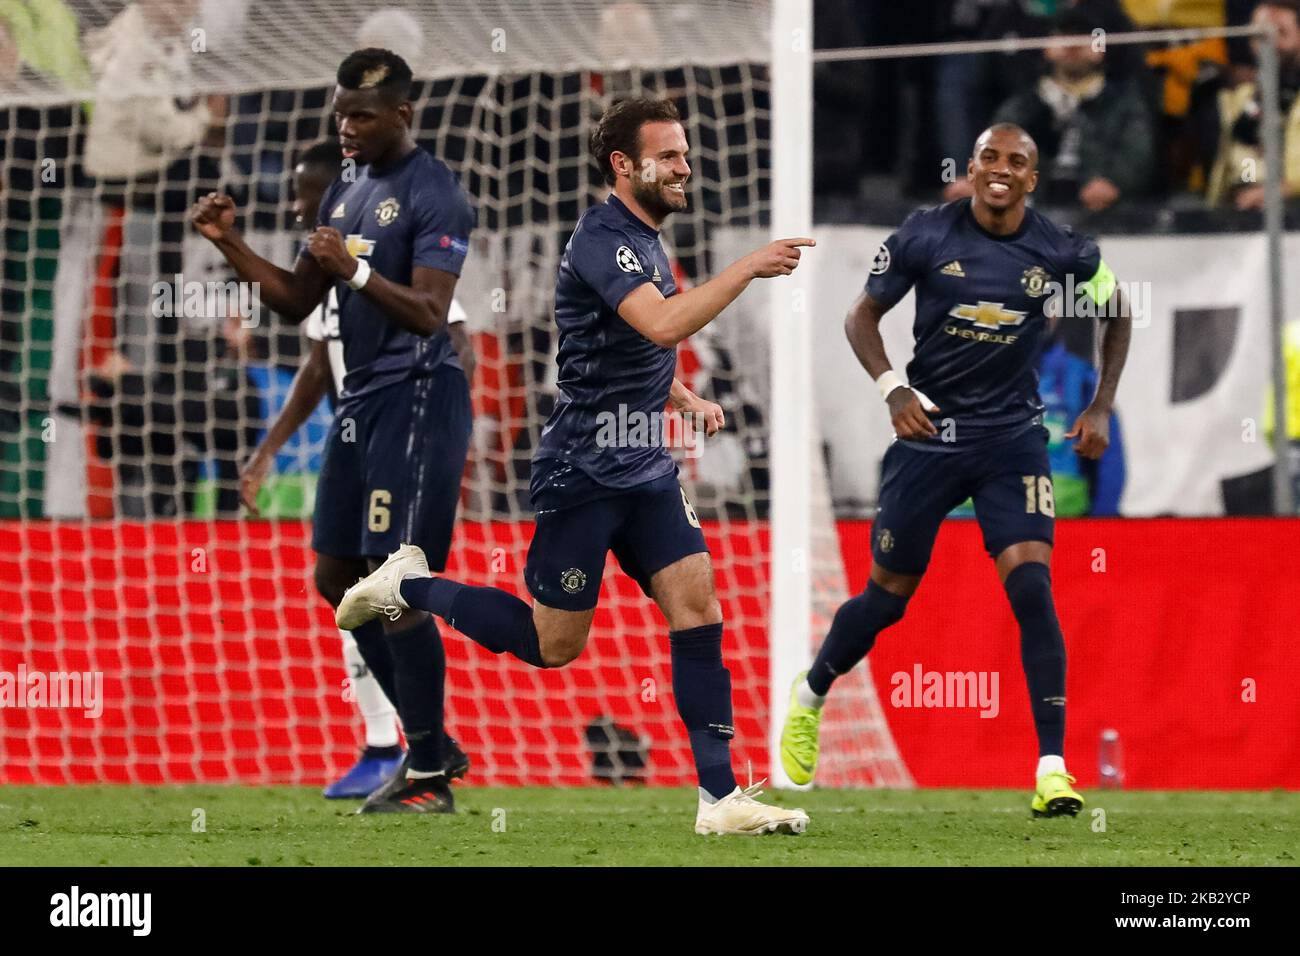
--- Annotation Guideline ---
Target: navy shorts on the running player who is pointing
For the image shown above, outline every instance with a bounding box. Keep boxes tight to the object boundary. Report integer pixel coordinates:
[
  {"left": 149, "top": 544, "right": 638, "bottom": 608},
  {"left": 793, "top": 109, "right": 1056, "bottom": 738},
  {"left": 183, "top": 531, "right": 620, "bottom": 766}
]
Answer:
[{"left": 524, "top": 466, "right": 709, "bottom": 611}]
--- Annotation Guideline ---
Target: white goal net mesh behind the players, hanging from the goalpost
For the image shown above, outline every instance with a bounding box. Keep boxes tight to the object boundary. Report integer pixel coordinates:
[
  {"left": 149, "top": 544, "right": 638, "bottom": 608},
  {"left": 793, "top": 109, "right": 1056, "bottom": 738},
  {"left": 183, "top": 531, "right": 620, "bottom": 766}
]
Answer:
[{"left": 0, "top": 0, "right": 910, "bottom": 786}]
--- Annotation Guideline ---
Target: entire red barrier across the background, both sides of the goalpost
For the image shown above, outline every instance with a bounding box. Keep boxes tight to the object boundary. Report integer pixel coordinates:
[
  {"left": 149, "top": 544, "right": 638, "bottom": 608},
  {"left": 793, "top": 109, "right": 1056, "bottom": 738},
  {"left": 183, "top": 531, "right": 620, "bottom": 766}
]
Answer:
[{"left": 0, "top": 519, "right": 1300, "bottom": 788}]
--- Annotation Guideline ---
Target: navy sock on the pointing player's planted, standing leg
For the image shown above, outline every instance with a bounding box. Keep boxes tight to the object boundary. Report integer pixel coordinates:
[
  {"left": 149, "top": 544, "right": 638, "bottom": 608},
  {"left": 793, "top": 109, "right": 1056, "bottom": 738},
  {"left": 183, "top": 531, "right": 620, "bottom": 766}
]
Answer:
[{"left": 668, "top": 623, "right": 736, "bottom": 800}]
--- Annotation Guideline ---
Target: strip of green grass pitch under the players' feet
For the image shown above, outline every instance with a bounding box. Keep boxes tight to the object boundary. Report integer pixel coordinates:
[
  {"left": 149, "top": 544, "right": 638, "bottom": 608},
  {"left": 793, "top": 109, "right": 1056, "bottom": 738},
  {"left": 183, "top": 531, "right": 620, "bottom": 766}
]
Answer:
[{"left": 0, "top": 787, "right": 1300, "bottom": 866}]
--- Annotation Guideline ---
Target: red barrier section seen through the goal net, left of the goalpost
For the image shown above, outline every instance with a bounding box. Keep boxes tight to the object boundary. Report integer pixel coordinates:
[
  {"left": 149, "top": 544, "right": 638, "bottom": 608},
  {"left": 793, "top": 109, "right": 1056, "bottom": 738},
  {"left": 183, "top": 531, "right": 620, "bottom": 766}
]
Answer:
[{"left": 0, "top": 522, "right": 767, "bottom": 786}]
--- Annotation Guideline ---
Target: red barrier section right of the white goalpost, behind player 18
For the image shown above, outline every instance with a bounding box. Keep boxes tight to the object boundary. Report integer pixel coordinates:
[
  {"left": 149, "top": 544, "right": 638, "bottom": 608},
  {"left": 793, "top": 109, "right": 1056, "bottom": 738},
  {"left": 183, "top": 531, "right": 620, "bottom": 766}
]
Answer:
[{"left": 840, "top": 518, "right": 1300, "bottom": 790}]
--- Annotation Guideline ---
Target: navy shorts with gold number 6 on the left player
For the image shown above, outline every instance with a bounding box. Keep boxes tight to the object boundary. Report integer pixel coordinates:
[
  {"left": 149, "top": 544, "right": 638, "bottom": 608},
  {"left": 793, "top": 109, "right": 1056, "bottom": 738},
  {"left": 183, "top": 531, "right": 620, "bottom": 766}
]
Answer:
[{"left": 312, "top": 367, "right": 473, "bottom": 571}]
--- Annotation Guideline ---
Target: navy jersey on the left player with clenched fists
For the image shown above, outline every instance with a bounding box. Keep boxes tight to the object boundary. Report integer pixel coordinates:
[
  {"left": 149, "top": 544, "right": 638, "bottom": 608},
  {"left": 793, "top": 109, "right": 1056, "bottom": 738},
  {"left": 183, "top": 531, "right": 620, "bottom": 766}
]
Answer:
[{"left": 303, "top": 147, "right": 475, "bottom": 398}]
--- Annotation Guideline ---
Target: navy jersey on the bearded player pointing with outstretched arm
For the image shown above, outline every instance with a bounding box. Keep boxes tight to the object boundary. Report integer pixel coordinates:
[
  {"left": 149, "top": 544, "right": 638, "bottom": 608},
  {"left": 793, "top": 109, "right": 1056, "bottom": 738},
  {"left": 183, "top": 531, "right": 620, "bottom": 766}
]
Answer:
[{"left": 533, "top": 195, "right": 677, "bottom": 494}]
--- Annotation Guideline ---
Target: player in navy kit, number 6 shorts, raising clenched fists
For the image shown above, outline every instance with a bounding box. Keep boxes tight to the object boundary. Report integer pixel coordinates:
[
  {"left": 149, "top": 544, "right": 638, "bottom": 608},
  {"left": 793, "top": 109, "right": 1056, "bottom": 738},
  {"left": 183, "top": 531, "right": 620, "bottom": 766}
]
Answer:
[{"left": 192, "top": 48, "right": 475, "bottom": 813}]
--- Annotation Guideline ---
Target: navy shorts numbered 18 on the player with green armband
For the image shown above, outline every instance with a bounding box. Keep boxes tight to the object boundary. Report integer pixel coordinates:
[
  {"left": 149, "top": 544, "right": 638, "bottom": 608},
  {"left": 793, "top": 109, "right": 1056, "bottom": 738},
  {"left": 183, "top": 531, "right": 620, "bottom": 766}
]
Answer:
[{"left": 871, "top": 424, "right": 1056, "bottom": 575}]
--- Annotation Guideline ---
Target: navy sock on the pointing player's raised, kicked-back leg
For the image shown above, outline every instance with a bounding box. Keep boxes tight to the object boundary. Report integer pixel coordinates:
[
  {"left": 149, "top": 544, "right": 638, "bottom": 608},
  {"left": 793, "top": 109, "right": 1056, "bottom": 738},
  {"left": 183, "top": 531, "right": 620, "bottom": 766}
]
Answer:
[{"left": 399, "top": 578, "right": 546, "bottom": 667}]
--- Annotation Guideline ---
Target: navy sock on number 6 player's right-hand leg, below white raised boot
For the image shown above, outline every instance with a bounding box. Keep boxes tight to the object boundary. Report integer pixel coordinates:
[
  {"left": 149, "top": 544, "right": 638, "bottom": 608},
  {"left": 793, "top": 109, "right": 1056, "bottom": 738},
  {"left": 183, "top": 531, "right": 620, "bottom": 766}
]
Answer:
[{"left": 382, "top": 618, "right": 447, "bottom": 774}]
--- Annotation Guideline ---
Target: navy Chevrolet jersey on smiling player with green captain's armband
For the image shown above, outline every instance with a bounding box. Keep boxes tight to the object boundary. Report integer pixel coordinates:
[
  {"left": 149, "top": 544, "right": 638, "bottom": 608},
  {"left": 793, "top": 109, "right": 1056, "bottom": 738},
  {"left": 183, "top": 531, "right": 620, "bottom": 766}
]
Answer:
[{"left": 866, "top": 199, "right": 1114, "bottom": 451}]
